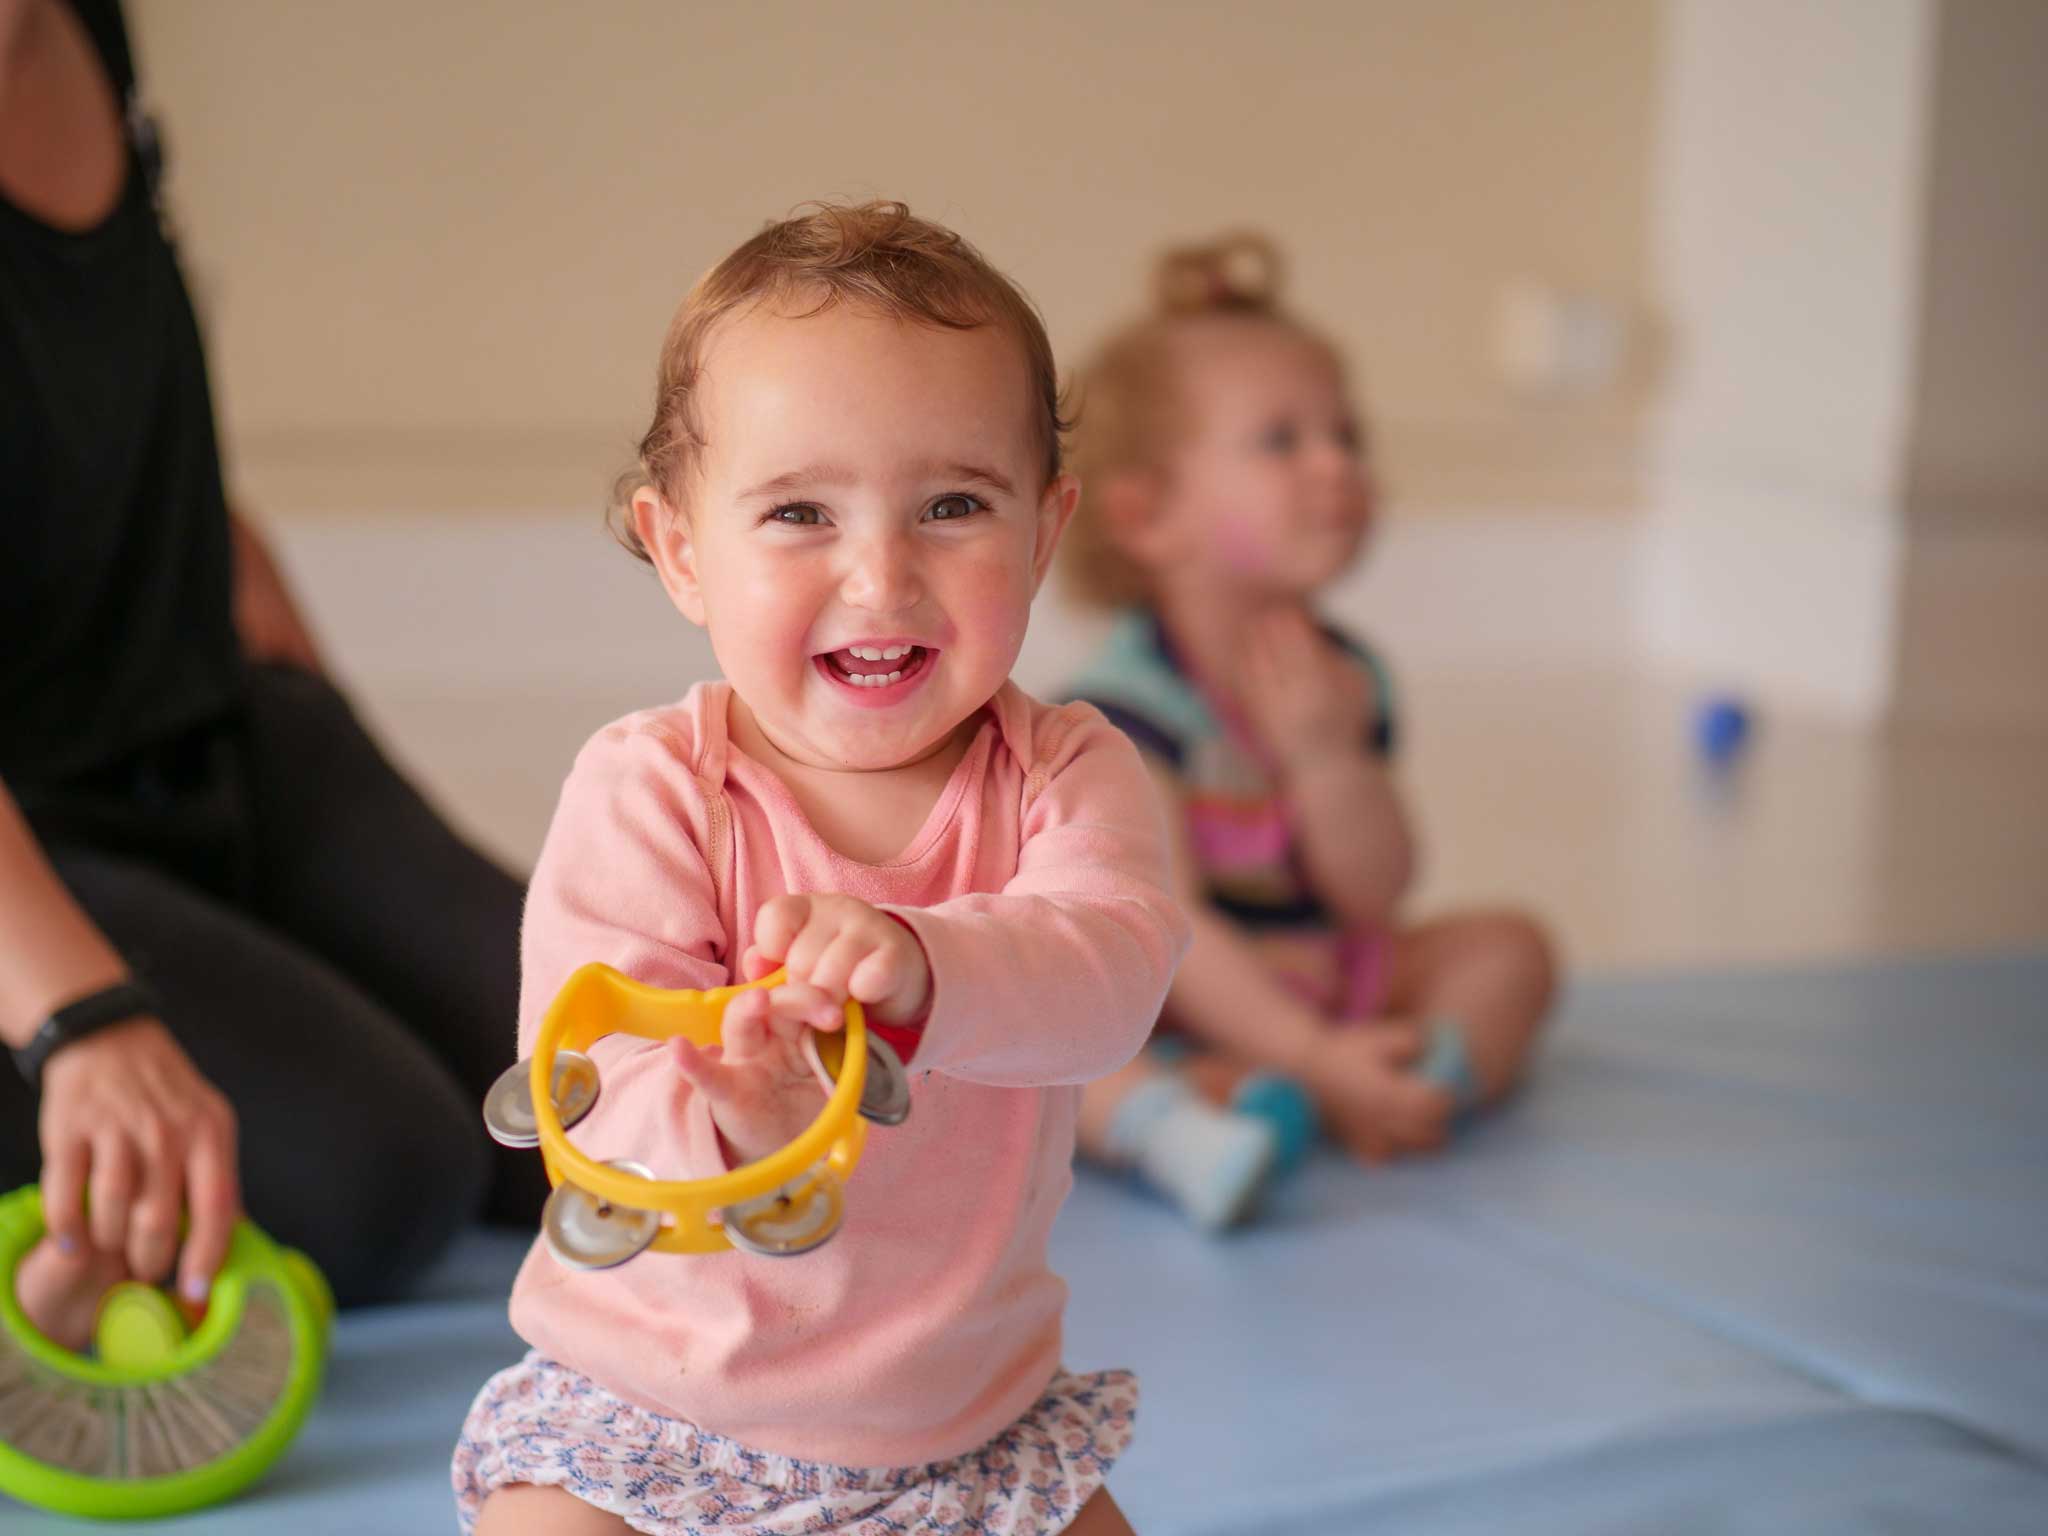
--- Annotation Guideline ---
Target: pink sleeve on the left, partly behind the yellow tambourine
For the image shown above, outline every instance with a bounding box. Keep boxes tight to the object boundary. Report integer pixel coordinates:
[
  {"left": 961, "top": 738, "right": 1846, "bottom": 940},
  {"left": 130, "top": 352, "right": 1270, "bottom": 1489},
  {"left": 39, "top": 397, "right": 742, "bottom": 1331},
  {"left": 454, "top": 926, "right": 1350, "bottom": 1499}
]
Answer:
[{"left": 518, "top": 725, "right": 729, "bottom": 1178}]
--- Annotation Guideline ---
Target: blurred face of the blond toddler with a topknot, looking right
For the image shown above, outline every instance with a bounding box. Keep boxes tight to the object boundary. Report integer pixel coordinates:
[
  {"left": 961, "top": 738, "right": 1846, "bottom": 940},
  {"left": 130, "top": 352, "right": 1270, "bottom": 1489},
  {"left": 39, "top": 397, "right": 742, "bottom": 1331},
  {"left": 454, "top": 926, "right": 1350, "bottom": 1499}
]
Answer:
[{"left": 1163, "top": 319, "right": 1372, "bottom": 596}]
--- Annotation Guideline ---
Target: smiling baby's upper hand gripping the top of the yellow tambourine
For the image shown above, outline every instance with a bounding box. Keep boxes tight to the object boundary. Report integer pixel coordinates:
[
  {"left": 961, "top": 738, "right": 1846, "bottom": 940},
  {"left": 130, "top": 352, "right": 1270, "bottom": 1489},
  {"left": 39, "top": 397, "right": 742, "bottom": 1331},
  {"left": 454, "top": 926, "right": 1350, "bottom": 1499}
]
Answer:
[{"left": 739, "top": 895, "right": 932, "bottom": 1024}]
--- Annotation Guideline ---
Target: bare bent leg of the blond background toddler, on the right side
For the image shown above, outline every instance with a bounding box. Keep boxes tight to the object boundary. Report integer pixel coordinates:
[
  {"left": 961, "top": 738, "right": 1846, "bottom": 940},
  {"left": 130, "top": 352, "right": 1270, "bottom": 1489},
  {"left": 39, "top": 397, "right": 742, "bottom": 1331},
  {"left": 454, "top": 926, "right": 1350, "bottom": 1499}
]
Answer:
[{"left": 1386, "top": 911, "right": 1556, "bottom": 1104}]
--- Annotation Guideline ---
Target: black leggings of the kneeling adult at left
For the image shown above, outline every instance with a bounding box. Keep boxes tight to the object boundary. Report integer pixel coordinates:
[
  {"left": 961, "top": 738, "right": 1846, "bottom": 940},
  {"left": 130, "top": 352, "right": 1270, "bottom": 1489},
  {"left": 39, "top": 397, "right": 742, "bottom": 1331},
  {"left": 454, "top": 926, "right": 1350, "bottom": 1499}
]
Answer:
[{"left": 0, "top": 668, "right": 545, "bottom": 1305}]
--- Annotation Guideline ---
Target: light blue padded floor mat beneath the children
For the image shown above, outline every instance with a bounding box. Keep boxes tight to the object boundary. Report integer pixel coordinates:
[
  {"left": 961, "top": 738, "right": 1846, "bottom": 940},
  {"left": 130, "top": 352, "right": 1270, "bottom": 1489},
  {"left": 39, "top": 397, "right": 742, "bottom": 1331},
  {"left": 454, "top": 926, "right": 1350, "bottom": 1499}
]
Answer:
[{"left": 16, "top": 956, "right": 2048, "bottom": 1536}]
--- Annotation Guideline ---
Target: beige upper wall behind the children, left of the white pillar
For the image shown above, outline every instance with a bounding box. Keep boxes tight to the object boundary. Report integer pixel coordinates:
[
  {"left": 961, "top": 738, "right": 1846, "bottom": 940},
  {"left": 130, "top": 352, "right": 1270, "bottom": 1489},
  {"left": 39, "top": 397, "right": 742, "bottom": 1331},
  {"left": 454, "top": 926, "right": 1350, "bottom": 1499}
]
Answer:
[{"left": 131, "top": 0, "right": 1659, "bottom": 512}]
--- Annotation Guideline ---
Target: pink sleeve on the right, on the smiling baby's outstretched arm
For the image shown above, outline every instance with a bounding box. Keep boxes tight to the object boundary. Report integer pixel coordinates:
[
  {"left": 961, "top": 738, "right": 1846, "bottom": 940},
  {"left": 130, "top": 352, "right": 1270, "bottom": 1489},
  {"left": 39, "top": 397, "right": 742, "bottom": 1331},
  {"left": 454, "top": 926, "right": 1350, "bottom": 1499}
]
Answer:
[{"left": 887, "top": 705, "right": 1188, "bottom": 1087}]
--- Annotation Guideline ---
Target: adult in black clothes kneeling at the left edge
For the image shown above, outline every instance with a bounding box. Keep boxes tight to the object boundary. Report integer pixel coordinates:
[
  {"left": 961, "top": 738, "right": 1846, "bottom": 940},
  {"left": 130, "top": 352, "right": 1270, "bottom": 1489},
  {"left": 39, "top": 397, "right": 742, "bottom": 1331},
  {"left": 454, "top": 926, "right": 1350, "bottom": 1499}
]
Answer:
[{"left": 0, "top": 0, "right": 543, "bottom": 1337}]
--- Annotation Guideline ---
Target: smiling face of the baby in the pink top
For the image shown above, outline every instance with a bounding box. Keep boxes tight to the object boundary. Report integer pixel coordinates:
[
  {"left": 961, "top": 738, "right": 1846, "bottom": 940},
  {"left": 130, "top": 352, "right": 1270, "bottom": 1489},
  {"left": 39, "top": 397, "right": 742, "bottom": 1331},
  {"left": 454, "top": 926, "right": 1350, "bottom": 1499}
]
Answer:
[{"left": 637, "top": 305, "right": 1075, "bottom": 770}]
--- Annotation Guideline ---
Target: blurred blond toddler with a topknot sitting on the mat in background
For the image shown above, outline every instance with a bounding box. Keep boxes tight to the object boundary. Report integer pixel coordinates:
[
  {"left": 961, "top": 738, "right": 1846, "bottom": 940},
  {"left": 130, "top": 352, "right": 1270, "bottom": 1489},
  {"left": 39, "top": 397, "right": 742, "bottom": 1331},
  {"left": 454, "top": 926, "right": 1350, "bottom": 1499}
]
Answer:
[{"left": 1063, "top": 238, "right": 1552, "bottom": 1225}]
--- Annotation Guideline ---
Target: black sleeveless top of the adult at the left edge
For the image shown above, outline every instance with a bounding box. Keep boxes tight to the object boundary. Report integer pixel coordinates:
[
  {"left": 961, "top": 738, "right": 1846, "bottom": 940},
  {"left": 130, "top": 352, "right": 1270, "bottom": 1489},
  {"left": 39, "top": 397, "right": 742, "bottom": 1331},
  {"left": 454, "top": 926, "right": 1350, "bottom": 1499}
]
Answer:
[{"left": 0, "top": 0, "right": 242, "bottom": 791}]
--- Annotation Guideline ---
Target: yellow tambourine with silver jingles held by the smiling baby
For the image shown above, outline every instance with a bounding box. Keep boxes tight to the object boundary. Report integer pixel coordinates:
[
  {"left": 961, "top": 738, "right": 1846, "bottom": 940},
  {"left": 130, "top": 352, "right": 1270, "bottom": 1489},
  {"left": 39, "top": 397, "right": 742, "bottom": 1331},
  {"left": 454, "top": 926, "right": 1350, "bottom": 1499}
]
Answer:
[{"left": 483, "top": 965, "right": 909, "bottom": 1270}]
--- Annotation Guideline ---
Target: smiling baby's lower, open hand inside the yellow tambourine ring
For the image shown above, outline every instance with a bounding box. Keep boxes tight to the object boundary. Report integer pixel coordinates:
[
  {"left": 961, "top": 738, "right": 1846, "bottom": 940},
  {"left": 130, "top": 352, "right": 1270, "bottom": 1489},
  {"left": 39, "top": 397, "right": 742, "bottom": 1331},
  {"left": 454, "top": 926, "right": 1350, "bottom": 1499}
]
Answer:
[{"left": 668, "top": 987, "right": 846, "bottom": 1163}]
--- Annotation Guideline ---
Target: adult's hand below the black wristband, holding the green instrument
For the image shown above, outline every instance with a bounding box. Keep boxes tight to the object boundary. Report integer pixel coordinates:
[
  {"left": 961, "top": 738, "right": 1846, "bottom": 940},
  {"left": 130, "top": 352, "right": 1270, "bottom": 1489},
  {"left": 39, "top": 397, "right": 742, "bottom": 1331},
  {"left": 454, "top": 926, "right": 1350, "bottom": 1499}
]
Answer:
[{"left": 41, "top": 1018, "right": 242, "bottom": 1303}]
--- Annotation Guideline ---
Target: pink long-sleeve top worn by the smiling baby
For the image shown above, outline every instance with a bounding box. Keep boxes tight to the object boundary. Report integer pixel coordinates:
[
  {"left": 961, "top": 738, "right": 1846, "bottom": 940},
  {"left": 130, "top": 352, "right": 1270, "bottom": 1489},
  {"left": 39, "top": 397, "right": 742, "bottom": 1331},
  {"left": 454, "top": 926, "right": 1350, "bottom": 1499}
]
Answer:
[{"left": 512, "top": 682, "right": 1188, "bottom": 1466}]
